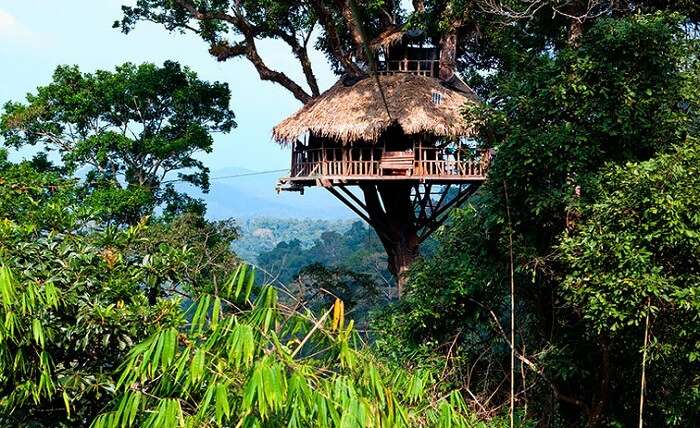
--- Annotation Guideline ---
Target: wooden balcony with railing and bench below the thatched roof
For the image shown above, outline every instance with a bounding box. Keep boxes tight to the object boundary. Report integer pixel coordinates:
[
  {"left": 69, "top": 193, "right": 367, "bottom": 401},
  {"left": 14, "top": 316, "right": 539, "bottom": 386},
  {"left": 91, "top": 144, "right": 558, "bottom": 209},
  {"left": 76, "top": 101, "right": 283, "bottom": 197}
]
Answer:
[{"left": 282, "top": 148, "right": 491, "bottom": 185}]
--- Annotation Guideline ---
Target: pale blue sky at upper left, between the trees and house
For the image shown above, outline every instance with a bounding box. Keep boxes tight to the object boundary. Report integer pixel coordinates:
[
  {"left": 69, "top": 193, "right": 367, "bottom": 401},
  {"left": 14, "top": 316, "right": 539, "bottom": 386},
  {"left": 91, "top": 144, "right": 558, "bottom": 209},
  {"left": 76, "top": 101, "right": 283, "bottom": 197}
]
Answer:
[{"left": 0, "top": 0, "right": 335, "bottom": 173}]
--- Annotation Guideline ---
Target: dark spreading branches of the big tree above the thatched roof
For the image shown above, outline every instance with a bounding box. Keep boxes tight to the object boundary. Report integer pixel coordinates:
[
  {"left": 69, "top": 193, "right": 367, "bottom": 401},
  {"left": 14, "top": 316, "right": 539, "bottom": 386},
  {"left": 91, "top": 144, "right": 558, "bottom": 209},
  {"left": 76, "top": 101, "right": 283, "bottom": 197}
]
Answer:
[{"left": 115, "top": 0, "right": 476, "bottom": 103}]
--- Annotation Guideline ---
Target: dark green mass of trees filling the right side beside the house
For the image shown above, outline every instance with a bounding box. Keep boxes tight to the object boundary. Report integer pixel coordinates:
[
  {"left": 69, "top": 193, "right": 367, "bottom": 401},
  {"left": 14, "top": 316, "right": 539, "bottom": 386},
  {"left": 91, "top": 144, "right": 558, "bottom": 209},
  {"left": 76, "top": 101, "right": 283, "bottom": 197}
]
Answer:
[{"left": 375, "top": 13, "right": 700, "bottom": 426}]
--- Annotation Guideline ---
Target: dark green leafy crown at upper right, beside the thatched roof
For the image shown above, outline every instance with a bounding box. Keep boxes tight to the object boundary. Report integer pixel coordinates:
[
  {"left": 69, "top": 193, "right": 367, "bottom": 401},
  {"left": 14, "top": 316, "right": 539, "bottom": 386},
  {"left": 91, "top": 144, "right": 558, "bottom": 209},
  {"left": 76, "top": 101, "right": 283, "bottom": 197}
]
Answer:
[{"left": 468, "top": 15, "right": 695, "bottom": 241}]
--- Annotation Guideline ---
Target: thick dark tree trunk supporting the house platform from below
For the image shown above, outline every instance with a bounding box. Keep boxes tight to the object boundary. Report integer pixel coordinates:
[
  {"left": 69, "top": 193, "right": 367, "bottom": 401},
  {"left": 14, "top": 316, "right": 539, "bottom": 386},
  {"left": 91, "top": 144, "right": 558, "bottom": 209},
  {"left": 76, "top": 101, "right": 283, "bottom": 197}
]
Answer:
[{"left": 361, "top": 183, "right": 420, "bottom": 298}]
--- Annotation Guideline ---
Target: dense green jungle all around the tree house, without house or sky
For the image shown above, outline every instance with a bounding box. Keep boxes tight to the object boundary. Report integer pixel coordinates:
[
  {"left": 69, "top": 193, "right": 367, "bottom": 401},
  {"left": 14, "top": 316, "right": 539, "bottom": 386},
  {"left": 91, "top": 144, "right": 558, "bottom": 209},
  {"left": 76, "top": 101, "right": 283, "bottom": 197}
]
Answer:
[{"left": 0, "top": 0, "right": 700, "bottom": 428}]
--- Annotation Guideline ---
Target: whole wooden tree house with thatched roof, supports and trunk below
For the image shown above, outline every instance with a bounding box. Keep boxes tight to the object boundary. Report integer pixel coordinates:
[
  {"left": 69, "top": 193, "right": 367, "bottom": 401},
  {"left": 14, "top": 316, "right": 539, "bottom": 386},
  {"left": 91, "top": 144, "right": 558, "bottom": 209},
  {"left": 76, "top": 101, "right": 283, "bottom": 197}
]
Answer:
[{"left": 273, "top": 33, "right": 491, "bottom": 296}]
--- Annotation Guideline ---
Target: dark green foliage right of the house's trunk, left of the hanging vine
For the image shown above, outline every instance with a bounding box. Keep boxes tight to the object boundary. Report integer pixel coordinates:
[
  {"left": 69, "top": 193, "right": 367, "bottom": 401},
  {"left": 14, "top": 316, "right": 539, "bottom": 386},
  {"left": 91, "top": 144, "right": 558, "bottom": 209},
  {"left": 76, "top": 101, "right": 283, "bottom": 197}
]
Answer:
[{"left": 371, "top": 201, "right": 516, "bottom": 416}]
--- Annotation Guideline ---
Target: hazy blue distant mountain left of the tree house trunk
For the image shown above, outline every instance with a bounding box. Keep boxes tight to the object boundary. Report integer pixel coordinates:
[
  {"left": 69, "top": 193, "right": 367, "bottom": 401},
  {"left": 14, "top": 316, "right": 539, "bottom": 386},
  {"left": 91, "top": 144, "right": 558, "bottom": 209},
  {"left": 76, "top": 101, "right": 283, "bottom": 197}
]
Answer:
[{"left": 178, "top": 167, "right": 355, "bottom": 220}]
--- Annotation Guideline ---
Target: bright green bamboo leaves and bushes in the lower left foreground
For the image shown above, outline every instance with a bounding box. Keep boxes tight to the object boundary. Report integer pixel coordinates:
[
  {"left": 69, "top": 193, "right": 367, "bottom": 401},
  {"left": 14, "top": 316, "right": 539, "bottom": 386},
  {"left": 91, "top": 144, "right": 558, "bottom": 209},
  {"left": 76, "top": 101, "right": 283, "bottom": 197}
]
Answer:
[{"left": 0, "top": 158, "right": 504, "bottom": 427}]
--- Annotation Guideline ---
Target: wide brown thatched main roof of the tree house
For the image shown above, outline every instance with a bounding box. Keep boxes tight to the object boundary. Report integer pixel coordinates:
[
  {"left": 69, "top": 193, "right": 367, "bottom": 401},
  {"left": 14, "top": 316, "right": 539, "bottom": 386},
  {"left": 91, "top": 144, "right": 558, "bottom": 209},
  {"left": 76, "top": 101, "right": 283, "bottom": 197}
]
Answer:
[{"left": 273, "top": 74, "right": 478, "bottom": 144}]
